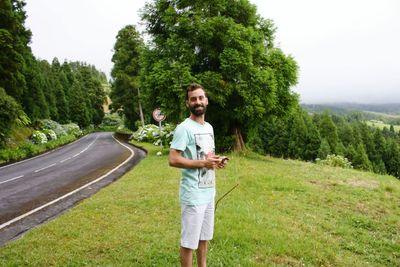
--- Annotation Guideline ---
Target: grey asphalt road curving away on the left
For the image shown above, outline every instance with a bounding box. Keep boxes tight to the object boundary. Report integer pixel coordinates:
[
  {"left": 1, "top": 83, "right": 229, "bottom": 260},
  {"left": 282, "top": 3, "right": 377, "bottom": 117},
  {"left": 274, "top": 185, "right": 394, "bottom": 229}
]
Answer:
[{"left": 0, "top": 132, "right": 145, "bottom": 244}]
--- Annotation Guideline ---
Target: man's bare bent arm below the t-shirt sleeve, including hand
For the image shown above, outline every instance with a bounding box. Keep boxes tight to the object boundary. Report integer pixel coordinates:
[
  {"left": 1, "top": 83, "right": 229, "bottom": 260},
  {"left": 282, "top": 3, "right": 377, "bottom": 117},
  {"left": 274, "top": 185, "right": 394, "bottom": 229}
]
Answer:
[{"left": 169, "top": 148, "right": 221, "bottom": 169}]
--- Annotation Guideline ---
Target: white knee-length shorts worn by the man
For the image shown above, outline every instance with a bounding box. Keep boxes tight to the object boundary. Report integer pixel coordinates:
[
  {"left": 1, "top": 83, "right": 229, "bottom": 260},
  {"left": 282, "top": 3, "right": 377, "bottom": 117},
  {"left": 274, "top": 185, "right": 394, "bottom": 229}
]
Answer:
[{"left": 181, "top": 202, "right": 214, "bottom": 249}]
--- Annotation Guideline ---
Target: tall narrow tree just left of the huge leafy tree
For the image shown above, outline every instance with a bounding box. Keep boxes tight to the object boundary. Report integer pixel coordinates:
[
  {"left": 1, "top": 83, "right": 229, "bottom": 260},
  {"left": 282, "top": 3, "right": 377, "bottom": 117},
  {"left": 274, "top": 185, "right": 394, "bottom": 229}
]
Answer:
[{"left": 110, "top": 25, "right": 144, "bottom": 129}]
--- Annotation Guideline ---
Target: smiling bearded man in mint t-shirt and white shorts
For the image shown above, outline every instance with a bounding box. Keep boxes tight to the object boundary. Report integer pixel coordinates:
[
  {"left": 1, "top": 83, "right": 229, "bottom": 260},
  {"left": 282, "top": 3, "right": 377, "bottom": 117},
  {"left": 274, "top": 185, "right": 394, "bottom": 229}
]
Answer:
[{"left": 169, "top": 84, "right": 225, "bottom": 266}]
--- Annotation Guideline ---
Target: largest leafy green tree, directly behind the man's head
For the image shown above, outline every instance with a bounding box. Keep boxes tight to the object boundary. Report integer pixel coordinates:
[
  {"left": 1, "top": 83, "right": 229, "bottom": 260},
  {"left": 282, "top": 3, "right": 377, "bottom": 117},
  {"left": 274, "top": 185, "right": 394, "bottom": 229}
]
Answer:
[{"left": 141, "top": 0, "right": 297, "bottom": 150}]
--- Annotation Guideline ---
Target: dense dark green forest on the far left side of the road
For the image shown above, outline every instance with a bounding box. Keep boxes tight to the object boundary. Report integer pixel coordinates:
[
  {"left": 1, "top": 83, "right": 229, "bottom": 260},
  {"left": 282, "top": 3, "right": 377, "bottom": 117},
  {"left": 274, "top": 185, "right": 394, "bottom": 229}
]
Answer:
[{"left": 0, "top": 0, "right": 107, "bottom": 146}]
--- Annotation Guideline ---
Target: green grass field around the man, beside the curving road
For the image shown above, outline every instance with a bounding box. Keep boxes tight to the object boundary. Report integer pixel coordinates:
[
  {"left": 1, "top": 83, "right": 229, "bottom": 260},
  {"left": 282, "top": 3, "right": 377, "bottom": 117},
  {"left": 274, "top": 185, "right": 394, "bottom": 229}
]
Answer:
[{"left": 0, "top": 145, "right": 400, "bottom": 267}]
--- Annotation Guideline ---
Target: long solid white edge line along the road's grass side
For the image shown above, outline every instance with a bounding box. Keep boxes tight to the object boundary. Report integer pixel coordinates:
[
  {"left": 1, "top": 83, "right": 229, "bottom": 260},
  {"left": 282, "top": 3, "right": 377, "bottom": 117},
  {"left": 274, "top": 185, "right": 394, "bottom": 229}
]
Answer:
[{"left": 0, "top": 136, "right": 135, "bottom": 230}]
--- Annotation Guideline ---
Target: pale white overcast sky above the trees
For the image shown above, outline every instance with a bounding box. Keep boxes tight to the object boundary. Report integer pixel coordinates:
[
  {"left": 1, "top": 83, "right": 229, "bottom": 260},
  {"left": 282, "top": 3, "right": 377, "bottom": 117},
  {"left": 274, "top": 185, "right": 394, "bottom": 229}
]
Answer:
[{"left": 25, "top": 0, "right": 400, "bottom": 103}]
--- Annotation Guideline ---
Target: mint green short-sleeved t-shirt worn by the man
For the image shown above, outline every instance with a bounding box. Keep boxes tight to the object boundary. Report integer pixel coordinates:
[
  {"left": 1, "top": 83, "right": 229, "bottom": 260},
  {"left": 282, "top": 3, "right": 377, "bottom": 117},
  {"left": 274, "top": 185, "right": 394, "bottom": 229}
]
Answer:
[{"left": 171, "top": 118, "right": 215, "bottom": 206}]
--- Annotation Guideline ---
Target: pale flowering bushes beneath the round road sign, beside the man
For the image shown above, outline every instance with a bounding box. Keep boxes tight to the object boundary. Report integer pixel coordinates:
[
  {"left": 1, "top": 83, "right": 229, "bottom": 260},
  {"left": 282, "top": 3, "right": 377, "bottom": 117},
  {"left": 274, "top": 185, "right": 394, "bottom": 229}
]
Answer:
[{"left": 132, "top": 123, "right": 175, "bottom": 146}]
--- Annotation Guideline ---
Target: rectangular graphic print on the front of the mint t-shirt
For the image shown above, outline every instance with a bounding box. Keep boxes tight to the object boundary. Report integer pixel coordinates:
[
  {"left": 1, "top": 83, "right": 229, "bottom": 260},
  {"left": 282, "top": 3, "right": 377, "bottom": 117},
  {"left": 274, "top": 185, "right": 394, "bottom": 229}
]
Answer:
[{"left": 194, "top": 133, "right": 215, "bottom": 188}]
